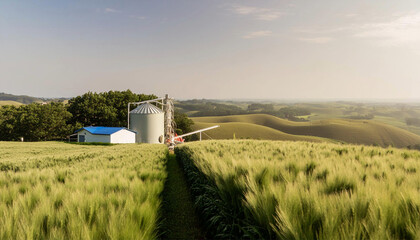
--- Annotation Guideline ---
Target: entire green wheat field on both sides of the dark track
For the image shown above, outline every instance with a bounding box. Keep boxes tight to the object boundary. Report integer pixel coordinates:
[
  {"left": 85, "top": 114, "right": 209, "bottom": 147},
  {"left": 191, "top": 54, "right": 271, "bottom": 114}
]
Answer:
[{"left": 0, "top": 140, "right": 420, "bottom": 239}]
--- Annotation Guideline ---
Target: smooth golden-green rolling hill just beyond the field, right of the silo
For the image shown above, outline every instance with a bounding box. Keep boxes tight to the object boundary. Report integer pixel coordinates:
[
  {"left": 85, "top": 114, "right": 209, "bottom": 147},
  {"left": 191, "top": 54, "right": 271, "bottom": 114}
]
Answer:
[{"left": 193, "top": 114, "right": 420, "bottom": 147}]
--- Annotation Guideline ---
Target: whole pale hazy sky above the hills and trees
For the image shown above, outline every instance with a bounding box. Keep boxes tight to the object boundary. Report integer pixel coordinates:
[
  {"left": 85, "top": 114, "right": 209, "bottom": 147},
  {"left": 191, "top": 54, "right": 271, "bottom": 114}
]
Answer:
[{"left": 0, "top": 0, "right": 420, "bottom": 99}]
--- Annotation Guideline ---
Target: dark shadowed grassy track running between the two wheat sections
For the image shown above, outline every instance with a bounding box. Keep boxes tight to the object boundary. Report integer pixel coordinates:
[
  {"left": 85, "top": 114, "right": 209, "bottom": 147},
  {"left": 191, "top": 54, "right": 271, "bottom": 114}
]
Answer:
[{"left": 160, "top": 154, "right": 205, "bottom": 239}]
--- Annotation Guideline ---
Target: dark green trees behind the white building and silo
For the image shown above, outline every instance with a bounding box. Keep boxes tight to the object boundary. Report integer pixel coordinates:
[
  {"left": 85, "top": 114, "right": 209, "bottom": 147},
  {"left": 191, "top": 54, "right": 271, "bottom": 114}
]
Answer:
[{"left": 0, "top": 90, "right": 193, "bottom": 141}]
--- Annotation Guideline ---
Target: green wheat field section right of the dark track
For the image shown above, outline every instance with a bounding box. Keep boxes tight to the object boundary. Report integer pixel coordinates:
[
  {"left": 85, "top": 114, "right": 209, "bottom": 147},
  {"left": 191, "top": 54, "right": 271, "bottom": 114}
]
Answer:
[{"left": 175, "top": 140, "right": 420, "bottom": 239}]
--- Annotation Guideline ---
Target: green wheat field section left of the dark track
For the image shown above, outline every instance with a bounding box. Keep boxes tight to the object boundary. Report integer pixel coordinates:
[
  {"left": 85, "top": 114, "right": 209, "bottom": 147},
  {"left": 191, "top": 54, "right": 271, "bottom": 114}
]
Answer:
[{"left": 0, "top": 142, "right": 167, "bottom": 239}]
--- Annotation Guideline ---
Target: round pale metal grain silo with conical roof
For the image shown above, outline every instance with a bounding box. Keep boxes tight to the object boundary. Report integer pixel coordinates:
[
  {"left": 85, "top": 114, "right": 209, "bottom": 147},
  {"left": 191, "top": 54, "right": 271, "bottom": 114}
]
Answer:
[{"left": 129, "top": 102, "right": 165, "bottom": 143}]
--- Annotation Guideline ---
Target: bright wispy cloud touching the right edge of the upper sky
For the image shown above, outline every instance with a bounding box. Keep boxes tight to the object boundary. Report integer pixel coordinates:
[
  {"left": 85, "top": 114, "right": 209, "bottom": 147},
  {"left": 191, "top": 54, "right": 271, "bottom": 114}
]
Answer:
[{"left": 354, "top": 12, "right": 420, "bottom": 46}]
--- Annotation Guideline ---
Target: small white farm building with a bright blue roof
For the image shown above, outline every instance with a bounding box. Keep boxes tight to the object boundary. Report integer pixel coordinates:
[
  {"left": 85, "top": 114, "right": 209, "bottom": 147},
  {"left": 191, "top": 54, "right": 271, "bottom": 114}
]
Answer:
[{"left": 76, "top": 126, "right": 137, "bottom": 143}]
